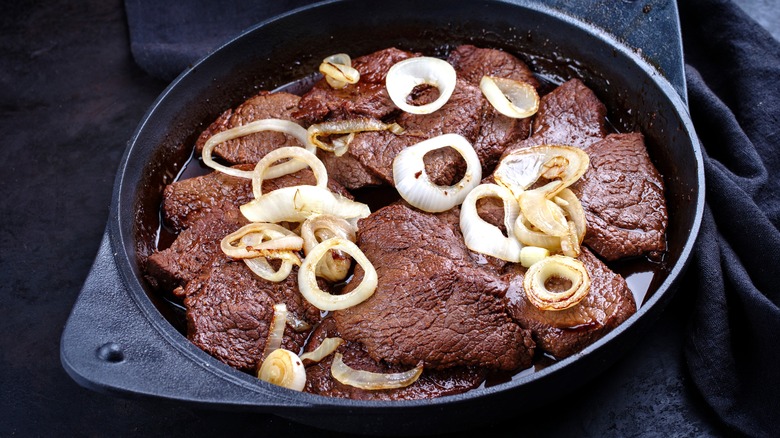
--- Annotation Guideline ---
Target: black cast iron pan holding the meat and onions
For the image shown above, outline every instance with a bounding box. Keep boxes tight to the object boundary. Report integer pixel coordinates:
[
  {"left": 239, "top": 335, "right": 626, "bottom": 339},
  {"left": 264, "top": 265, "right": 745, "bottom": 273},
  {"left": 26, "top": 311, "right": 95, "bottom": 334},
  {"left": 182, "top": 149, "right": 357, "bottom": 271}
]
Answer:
[{"left": 61, "top": 0, "right": 704, "bottom": 434}]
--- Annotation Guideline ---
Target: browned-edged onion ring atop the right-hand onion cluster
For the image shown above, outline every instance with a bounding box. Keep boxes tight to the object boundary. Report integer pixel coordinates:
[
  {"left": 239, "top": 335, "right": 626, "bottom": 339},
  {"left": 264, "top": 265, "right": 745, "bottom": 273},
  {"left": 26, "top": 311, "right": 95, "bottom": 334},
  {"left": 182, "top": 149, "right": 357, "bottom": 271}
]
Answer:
[{"left": 493, "top": 144, "right": 590, "bottom": 199}]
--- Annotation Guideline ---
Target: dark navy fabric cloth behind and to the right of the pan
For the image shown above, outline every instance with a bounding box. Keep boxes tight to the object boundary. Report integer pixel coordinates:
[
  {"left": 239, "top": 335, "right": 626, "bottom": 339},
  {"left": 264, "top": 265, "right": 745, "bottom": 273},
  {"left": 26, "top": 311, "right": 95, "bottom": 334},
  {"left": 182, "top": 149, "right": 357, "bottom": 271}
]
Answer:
[{"left": 125, "top": 0, "right": 780, "bottom": 436}]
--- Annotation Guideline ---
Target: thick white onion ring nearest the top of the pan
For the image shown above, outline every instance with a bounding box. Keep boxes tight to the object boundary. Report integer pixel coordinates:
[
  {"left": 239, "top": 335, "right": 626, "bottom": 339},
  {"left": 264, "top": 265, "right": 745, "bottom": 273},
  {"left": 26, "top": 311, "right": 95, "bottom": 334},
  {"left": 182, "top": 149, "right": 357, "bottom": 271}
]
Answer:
[{"left": 385, "top": 56, "right": 457, "bottom": 114}]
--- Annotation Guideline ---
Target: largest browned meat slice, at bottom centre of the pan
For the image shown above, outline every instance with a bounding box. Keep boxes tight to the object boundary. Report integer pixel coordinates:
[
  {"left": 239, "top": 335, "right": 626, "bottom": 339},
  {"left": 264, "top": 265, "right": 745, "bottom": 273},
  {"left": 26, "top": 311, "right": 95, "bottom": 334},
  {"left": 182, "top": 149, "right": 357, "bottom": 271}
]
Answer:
[{"left": 334, "top": 203, "right": 534, "bottom": 371}]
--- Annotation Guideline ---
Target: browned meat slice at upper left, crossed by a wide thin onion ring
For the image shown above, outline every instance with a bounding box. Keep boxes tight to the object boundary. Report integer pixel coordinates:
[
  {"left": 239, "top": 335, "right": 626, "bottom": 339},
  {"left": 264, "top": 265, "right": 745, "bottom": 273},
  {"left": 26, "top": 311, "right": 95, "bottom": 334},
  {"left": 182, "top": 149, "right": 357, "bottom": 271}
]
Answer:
[{"left": 195, "top": 92, "right": 300, "bottom": 164}]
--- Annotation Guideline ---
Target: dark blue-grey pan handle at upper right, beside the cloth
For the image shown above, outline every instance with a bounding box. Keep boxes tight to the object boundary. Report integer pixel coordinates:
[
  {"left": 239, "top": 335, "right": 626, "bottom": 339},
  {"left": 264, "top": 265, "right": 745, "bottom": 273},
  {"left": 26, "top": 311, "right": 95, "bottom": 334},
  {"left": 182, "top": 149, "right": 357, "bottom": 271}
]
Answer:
[{"left": 541, "top": 0, "right": 688, "bottom": 103}]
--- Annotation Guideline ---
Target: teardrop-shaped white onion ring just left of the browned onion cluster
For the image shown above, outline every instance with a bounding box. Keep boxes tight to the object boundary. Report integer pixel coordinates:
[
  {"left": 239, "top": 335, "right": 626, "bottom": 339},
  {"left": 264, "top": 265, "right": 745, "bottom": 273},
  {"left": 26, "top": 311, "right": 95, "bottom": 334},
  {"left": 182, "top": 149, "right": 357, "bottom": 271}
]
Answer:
[{"left": 460, "top": 184, "right": 523, "bottom": 263}]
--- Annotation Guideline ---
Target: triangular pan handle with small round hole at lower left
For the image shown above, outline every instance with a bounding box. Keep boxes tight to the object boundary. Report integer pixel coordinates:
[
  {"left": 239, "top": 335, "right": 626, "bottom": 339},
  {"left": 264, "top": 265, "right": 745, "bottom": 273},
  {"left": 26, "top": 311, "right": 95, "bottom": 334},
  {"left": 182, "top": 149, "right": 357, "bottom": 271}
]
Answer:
[{"left": 60, "top": 232, "right": 309, "bottom": 412}]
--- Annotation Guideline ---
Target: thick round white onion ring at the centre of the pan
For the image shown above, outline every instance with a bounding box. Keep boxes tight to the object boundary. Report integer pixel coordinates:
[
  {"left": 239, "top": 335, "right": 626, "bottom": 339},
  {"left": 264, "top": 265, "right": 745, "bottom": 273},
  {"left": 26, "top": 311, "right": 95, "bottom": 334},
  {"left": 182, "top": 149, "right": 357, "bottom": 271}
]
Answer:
[{"left": 393, "top": 134, "right": 482, "bottom": 213}]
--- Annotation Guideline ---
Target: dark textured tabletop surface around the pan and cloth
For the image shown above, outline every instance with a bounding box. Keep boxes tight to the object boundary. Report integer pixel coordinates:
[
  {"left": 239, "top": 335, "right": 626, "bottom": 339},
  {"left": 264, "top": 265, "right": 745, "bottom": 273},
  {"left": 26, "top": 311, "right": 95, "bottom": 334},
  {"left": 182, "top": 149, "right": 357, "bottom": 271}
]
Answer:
[{"left": 0, "top": 0, "right": 780, "bottom": 437}]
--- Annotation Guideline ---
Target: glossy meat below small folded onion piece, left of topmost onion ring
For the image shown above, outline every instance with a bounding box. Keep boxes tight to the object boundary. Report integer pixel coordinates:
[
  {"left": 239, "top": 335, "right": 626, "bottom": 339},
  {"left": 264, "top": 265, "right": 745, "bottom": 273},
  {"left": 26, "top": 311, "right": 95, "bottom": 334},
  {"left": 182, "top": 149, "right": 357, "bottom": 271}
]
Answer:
[{"left": 293, "top": 48, "right": 418, "bottom": 125}]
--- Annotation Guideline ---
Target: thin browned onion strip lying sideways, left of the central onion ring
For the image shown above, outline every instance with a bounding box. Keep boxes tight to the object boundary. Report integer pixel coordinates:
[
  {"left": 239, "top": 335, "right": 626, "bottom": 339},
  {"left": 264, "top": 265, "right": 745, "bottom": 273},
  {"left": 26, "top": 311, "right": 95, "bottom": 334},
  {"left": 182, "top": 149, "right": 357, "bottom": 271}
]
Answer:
[{"left": 306, "top": 118, "right": 404, "bottom": 157}]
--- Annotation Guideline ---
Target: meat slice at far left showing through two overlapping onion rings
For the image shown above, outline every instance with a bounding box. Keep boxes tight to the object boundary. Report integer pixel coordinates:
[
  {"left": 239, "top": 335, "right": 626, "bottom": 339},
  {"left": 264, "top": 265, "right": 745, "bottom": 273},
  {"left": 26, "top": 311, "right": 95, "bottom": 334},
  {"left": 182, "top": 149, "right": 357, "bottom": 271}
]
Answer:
[{"left": 162, "top": 164, "right": 352, "bottom": 231}]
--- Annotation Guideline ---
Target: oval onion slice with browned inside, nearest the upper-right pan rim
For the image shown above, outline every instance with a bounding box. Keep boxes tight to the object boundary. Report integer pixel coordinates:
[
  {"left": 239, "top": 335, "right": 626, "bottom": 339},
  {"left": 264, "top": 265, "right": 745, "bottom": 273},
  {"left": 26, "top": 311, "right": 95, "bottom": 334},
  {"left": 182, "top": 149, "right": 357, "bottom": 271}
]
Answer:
[{"left": 479, "top": 76, "right": 539, "bottom": 119}]
